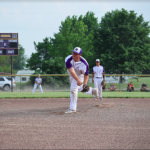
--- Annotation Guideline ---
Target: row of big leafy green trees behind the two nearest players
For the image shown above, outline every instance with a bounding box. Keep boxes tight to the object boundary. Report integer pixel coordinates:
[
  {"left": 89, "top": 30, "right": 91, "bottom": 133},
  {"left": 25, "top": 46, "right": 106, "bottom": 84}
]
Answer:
[{"left": 27, "top": 9, "right": 150, "bottom": 74}]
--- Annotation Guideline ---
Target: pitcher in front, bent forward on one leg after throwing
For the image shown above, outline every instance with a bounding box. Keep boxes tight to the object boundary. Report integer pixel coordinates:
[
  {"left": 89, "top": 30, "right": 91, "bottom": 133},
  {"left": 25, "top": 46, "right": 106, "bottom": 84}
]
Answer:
[{"left": 65, "top": 47, "right": 98, "bottom": 113}]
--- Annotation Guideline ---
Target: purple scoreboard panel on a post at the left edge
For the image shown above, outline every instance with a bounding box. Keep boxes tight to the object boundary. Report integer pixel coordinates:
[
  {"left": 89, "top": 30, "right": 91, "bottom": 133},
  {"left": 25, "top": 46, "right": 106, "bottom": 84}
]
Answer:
[{"left": 0, "top": 33, "right": 19, "bottom": 56}]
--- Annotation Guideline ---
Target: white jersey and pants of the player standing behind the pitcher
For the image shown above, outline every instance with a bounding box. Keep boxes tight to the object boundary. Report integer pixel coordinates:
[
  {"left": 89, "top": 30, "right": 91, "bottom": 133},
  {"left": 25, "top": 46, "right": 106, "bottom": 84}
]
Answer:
[{"left": 93, "top": 65, "right": 105, "bottom": 98}]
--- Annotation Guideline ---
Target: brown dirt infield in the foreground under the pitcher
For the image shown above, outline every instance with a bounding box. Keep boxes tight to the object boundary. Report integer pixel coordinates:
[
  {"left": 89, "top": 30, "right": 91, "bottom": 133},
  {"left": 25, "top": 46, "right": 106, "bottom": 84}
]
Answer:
[{"left": 0, "top": 98, "right": 150, "bottom": 149}]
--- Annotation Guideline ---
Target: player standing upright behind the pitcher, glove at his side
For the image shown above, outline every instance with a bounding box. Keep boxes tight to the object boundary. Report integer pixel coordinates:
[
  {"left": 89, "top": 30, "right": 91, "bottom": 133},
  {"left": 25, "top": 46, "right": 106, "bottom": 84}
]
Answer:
[{"left": 92, "top": 59, "right": 105, "bottom": 100}]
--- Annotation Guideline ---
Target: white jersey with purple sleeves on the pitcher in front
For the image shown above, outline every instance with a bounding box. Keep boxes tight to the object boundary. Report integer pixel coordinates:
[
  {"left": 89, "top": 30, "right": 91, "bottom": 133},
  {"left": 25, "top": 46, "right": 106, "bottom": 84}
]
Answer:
[{"left": 65, "top": 55, "right": 89, "bottom": 75}]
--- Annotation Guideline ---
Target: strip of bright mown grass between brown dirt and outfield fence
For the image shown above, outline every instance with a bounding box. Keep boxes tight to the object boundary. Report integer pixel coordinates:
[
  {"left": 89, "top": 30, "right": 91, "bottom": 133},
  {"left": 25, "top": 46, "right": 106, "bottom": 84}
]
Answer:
[{"left": 0, "top": 91, "right": 150, "bottom": 99}]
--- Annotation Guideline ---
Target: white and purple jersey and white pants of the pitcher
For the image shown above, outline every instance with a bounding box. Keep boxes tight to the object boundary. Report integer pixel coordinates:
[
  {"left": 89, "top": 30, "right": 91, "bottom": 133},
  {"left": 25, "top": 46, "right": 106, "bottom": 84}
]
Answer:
[{"left": 65, "top": 55, "right": 92, "bottom": 111}]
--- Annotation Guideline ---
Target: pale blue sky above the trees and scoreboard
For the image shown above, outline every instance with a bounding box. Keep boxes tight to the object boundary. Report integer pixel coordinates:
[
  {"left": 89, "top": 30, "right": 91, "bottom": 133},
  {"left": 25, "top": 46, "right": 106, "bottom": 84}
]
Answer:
[{"left": 0, "top": 0, "right": 150, "bottom": 58}]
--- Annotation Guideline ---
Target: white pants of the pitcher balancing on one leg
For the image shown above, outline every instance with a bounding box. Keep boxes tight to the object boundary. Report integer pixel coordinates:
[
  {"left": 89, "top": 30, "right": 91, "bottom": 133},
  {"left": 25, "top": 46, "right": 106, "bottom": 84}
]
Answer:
[{"left": 70, "top": 76, "right": 92, "bottom": 111}]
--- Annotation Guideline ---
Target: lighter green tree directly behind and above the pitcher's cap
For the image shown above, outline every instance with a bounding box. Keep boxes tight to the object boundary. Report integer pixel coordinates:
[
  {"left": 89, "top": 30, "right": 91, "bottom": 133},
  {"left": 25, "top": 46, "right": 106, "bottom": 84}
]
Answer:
[{"left": 54, "top": 16, "right": 93, "bottom": 58}]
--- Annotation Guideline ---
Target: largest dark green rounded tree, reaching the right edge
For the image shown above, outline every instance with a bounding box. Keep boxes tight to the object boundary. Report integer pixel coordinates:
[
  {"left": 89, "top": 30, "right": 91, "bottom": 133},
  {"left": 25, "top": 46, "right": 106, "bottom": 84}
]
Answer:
[{"left": 95, "top": 9, "right": 150, "bottom": 81}]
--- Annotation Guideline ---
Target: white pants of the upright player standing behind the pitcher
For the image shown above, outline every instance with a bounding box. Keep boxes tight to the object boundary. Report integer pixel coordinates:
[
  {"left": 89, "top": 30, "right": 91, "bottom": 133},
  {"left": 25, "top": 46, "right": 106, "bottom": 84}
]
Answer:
[{"left": 94, "top": 78, "right": 103, "bottom": 97}]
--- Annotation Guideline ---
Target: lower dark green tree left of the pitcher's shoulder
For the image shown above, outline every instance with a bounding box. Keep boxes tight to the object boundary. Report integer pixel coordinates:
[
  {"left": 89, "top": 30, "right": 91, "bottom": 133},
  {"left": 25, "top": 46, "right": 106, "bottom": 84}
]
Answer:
[{"left": 26, "top": 37, "right": 66, "bottom": 74}]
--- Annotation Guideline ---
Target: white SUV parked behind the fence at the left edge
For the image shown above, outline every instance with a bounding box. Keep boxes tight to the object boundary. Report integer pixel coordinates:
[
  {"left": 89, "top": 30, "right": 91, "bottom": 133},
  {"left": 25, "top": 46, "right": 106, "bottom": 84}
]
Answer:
[{"left": 0, "top": 77, "right": 16, "bottom": 91}]
